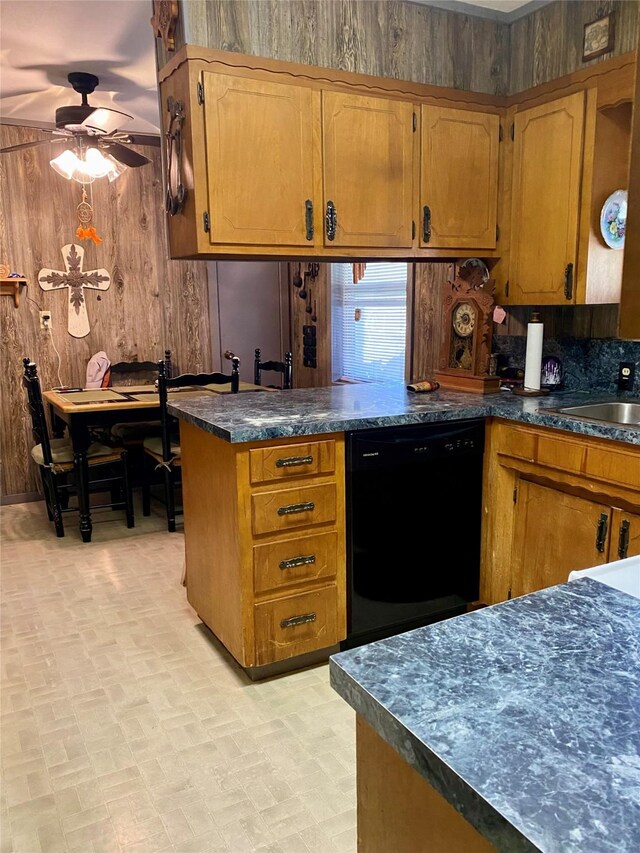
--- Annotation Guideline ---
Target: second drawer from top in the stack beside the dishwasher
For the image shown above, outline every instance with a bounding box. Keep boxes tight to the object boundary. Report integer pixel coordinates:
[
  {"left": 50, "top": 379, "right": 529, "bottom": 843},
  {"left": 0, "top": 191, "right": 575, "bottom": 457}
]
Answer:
[{"left": 251, "top": 483, "right": 337, "bottom": 536}]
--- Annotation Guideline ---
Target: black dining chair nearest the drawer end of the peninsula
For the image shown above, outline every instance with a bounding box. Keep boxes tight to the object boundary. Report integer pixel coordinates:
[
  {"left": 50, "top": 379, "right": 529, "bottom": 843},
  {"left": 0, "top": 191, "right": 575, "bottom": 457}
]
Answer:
[{"left": 142, "top": 356, "right": 240, "bottom": 533}]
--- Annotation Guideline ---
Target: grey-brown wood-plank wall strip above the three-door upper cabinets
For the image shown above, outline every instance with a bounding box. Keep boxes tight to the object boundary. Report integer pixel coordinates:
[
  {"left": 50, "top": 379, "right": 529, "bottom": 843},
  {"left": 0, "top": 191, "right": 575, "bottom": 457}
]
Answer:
[{"left": 171, "top": 0, "right": 509, "bottom": 95}]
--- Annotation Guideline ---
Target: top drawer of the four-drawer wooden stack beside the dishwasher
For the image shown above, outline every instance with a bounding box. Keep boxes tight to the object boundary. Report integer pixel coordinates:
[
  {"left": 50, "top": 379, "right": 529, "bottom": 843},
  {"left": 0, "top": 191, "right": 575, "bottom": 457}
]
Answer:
[{"left": 249, "top": 440, "right": 336, "bottom": 484}]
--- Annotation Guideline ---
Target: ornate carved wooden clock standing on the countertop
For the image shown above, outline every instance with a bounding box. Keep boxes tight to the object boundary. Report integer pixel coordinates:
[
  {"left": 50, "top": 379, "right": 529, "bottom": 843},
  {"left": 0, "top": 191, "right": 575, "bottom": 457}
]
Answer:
[{"left": 435, "top": 265, "right": 500, "bottom": 394}]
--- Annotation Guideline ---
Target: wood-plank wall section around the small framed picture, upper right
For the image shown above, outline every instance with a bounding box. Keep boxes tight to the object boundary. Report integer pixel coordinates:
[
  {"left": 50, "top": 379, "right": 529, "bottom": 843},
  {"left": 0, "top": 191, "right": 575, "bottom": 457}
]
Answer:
[{"left": 509, "top": 0, "right": 640, "bottom": 94}]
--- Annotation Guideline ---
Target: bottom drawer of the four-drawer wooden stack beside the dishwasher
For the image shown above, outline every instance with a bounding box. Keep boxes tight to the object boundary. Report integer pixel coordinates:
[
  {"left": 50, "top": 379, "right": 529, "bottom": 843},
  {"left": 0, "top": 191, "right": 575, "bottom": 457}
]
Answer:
[{"left": 254, "top": 585, "right": 345, "bottom": 666}]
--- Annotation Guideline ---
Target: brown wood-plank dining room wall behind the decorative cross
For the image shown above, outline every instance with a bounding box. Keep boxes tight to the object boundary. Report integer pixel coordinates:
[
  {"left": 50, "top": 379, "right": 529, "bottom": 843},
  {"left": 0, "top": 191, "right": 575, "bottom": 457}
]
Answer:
[{"left": 0, "top": 125, "right": 211, "bottom": 497}]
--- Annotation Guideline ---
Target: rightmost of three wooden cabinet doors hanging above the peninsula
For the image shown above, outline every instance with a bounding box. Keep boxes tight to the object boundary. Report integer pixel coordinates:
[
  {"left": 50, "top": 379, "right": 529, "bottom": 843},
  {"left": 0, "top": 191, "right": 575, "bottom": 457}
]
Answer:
[{"left": 420, "top": 104, "right": 500, "bottom": 249}]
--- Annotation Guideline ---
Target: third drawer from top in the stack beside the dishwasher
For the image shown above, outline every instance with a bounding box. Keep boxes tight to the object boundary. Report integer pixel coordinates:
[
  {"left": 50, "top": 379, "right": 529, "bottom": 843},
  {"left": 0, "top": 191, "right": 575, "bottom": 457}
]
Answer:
[{"left": 253, "top": 531, "right": 338, "bottom": 592}]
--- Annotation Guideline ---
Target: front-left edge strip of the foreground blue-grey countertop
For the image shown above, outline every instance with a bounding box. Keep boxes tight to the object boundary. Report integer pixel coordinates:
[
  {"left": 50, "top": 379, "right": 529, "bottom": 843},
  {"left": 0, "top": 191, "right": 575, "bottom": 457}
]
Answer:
[{"left": 329, "top": 657, "right": 539, "bottom": 853}]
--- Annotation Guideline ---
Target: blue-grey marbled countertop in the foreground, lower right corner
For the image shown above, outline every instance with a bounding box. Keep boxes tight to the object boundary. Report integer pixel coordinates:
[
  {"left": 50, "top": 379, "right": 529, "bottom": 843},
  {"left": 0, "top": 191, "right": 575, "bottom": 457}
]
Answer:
[{"left": 330, "top": 578, "right": 640, "bottom": 853}]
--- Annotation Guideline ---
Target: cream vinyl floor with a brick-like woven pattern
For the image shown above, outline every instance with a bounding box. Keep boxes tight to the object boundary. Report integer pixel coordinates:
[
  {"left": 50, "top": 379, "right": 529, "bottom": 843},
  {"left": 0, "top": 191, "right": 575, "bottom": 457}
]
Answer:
[{"left": 0, "top": 502, "right": 356, "bottom": 853}]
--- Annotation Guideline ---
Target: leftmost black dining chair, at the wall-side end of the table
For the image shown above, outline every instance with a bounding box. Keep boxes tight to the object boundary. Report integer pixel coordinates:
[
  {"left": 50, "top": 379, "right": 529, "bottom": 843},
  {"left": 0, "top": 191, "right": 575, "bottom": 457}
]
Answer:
[{"left": 22, "top": 358, "right": 135, "bottom": 536}]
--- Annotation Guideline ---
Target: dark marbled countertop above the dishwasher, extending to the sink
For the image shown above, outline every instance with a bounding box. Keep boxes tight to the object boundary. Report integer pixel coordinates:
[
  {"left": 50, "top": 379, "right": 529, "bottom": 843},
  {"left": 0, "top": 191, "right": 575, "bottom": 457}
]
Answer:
[{"left": 169, "top": 384, "right": 640, "bottom": 445}]
